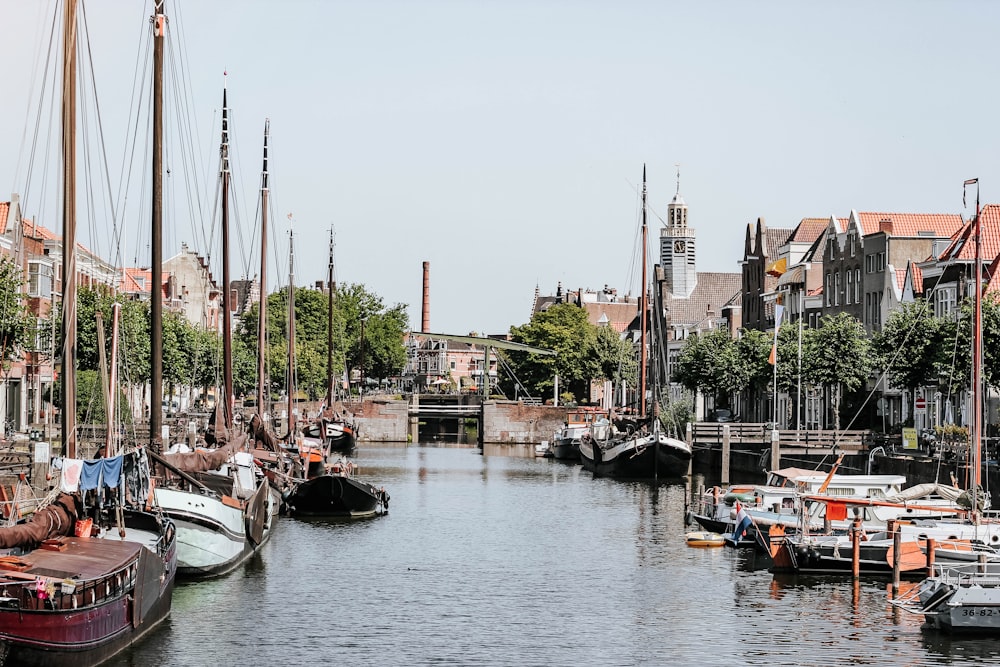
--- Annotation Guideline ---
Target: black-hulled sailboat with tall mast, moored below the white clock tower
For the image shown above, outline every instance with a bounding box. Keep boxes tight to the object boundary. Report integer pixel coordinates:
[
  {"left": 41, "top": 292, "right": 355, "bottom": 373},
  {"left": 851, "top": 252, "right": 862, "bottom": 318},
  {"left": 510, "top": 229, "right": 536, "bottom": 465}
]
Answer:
[{"left": 580, "top": 166, "right": 691, "bottom": 479}]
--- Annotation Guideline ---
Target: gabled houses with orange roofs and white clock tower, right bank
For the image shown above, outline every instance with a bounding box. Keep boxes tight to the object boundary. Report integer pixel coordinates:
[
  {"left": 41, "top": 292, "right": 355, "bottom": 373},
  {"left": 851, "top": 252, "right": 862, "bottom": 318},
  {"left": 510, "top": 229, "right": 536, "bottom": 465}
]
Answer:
[{"left": 533, "top": 176, "right": 1000, "bottom": 428}]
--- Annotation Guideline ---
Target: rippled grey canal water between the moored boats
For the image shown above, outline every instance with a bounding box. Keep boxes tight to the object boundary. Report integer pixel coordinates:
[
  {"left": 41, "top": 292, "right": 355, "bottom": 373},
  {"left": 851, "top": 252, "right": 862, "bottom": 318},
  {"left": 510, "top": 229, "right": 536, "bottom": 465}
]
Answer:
[{"left": 111, "top": 445, "right": 1000, "bottom": 667}]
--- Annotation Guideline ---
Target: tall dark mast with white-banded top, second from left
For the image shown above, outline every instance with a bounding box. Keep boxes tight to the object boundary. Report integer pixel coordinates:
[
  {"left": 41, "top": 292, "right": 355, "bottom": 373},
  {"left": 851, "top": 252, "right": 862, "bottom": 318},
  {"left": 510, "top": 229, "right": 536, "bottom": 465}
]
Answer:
[{"left": 149, "top": 0, "right": 167, "bottom": 452}]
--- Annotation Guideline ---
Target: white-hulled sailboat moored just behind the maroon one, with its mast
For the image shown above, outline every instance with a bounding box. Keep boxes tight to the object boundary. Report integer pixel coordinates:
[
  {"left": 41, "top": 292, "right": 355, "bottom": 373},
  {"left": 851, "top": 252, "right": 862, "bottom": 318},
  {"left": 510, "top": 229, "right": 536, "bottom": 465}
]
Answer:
[{"left": 153, "top": 89, "right": 277, "bottom": 578}]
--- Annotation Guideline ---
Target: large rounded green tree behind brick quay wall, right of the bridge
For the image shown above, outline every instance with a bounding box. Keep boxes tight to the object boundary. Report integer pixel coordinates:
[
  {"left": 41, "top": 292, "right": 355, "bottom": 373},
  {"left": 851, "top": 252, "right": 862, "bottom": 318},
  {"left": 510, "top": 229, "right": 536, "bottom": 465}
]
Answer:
[{"left": 507, "top": 303, "right": 596, "bottom": 398}]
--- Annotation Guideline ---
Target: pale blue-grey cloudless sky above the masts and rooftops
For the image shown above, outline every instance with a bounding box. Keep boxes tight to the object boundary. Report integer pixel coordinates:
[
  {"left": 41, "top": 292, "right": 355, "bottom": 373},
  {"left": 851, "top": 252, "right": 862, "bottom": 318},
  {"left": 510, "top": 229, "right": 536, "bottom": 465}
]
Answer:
[{"left": 0, "top": 0, "right": 1000, "bottom": 334}]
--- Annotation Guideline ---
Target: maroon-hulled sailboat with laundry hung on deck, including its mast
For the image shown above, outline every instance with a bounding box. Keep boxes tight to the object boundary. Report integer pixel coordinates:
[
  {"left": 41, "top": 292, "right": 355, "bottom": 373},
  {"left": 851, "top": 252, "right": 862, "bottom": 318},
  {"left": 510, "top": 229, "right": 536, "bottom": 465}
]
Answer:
[{"left": 0, "top": 0, "right": 177, "bottom": 667}]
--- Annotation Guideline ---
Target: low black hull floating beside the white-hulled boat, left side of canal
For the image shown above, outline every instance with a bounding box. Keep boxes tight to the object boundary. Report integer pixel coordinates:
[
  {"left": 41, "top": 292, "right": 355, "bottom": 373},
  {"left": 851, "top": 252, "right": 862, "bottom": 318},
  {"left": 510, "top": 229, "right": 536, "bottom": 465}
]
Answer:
[{"left": 285, "top": 474, "right": 389, "bottom": 519}]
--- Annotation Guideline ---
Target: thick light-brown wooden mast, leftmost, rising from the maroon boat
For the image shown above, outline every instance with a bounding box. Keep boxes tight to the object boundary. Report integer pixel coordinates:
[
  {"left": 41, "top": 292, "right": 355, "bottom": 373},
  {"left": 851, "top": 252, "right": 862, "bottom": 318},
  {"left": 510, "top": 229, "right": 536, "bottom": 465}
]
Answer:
[{"left": 60, "top": 0, "right": 76, "bottom": 458}]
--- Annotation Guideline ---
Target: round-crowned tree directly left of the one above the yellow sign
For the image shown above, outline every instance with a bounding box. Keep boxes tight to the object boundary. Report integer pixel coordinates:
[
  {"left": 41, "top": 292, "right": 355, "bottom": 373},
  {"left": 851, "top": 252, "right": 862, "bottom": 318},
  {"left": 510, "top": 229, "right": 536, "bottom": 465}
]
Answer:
[{"left": 802, "top": 313, "right": 872, "bottom": 429}]
